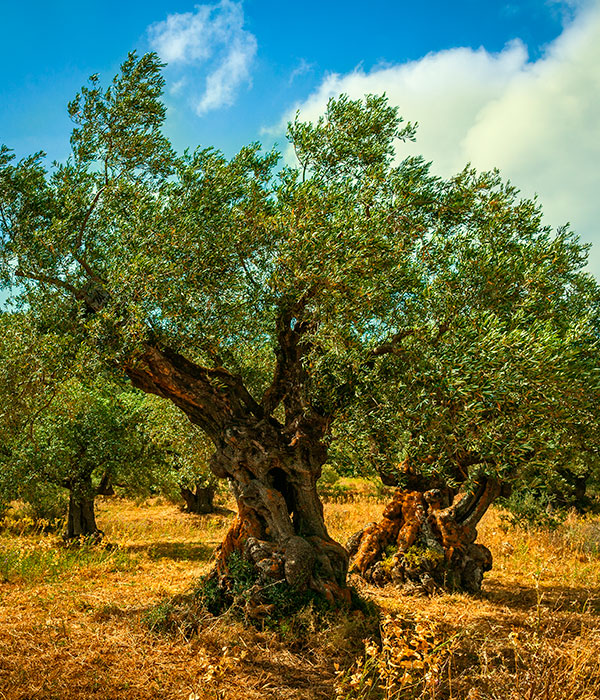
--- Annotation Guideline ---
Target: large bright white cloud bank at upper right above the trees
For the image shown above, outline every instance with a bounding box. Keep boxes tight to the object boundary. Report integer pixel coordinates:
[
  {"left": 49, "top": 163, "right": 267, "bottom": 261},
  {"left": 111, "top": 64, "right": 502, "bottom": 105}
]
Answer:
[{"left": 285, "top": 0, "right": 600, "bottom": 276}]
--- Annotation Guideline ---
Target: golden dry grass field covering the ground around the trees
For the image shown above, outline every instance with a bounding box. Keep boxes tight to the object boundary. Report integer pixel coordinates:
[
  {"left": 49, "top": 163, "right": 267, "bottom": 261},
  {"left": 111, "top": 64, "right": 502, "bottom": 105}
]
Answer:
[{"left": 0, "top": 497, "right": 600, "bottom": 700}]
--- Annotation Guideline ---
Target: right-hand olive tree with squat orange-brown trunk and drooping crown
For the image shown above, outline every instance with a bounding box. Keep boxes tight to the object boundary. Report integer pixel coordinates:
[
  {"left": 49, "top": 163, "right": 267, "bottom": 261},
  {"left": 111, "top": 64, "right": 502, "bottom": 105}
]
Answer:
[{"left": 340, "top": 306, "right": 600, "bottom": 591}]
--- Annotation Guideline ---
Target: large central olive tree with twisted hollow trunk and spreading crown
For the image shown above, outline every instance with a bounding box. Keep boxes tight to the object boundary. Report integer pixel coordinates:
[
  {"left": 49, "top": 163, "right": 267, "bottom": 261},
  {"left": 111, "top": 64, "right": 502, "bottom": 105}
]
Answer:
[{"left": 0, "top": 54, "right": 590, "bottom": 602}]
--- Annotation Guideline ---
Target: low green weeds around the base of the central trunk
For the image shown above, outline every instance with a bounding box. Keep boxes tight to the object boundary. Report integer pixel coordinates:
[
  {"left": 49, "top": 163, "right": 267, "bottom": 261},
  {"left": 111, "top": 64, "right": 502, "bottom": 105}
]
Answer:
[{"left": 144, "top": 552, "right": 379, "bottom": 642}]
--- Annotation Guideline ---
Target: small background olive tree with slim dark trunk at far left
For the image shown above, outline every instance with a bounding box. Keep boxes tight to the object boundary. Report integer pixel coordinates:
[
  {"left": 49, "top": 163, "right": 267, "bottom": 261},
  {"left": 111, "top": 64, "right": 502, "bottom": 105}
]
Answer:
[{"left": 3, "top": 379, "right": 175, "bottom": 539}]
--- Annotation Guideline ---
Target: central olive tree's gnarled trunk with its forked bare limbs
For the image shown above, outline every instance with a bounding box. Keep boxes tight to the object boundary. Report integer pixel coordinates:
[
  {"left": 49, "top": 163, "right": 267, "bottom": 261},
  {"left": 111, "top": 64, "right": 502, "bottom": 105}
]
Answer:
[{"left": 126, "top": 342, "right": 350, "bottom": 605}]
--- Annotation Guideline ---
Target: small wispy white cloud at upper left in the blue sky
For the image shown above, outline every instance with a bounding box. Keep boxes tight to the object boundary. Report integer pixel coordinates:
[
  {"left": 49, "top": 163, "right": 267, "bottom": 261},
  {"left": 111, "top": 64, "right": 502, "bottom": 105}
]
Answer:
[{"left": 148, "top": 0, "right": 256, "bottom": 115}]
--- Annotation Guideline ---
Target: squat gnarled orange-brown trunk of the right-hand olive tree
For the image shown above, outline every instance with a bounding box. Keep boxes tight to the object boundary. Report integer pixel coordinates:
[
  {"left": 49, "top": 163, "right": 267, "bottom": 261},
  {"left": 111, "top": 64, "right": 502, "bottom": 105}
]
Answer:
[{"left": 346, "top": 477, "right": 500, "bottom": 593}]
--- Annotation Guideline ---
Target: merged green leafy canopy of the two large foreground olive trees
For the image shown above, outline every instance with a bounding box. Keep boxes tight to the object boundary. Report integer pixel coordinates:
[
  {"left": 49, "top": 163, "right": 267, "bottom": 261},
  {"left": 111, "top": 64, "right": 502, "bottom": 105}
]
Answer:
[{"left": 0, "top": 54, "right": 600, "bottom": 552}]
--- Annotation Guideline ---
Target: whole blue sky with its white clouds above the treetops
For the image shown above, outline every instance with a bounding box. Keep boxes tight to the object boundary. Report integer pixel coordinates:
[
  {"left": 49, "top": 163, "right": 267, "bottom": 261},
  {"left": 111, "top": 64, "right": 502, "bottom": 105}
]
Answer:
[{"left": 0, "top": 0, "right": 600, "bottom": 276}]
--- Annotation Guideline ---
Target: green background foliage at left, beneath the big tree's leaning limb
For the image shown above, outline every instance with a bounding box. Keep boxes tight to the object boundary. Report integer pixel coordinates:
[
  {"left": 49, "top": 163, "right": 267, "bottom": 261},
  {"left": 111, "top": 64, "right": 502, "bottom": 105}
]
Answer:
[{"left": 0, "top": 312, "right": 216, "bottom": 523}]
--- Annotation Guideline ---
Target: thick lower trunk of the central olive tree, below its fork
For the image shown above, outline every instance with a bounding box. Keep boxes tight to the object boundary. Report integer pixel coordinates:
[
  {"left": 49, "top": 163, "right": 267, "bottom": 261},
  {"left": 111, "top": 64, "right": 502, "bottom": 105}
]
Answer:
[{"left": 212, "top": 425, "right": 350, "bottom": 605}]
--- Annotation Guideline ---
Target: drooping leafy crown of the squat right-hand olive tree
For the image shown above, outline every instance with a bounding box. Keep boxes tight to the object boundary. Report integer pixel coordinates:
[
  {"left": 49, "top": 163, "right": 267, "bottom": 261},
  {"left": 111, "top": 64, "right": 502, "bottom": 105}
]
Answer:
[{"left": 330, "top": 300, "right": 600, "bottom": 493}]
